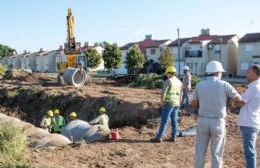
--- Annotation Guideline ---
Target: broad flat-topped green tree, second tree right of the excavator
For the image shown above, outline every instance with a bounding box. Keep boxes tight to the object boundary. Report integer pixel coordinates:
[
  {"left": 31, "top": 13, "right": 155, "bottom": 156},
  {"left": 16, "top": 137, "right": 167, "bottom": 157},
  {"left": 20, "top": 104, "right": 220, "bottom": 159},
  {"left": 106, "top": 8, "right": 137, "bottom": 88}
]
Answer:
[{"left": 102, "top": 42, "right": 122, "bottom": 70}]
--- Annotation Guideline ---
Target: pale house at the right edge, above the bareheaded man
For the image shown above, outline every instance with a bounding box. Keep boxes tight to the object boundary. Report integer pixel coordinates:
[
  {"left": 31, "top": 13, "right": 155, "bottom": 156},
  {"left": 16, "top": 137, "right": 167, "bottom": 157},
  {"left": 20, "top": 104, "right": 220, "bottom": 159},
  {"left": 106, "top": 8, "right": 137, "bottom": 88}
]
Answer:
[{"left": 237, "top": 33, "right": 260, "bottom": 76}]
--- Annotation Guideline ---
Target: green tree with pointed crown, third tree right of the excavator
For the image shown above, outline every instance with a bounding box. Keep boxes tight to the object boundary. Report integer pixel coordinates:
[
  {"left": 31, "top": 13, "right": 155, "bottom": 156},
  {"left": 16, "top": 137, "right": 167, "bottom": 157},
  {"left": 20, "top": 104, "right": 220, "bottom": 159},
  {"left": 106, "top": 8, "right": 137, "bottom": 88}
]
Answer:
[{"left": 125, "top": 44, "right": 145, "bottom": 74}]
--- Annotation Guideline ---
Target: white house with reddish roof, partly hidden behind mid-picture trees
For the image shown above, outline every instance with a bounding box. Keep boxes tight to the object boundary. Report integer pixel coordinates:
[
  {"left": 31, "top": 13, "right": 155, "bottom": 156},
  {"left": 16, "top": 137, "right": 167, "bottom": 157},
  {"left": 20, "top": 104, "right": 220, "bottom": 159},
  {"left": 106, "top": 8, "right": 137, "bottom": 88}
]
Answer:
[{"left": 116, "top": 35, "right": 172, "bottom": 74}]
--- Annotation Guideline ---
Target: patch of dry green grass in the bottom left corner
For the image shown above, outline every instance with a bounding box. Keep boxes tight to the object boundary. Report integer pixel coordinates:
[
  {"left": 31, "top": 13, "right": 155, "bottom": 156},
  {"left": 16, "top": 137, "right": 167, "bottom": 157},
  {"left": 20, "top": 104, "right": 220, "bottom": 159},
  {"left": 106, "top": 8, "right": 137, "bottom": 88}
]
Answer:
[{"left": 0, "top": 122, "right": 31, "bottom": 168}]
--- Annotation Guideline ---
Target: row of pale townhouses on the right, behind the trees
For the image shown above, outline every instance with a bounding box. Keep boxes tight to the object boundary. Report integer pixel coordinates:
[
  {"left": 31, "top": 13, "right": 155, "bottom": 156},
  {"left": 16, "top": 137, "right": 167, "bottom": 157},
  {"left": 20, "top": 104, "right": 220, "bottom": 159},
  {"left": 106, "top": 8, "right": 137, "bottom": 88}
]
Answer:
[{"left": 117, "top": 29, "right": 260, "bottom": 76}]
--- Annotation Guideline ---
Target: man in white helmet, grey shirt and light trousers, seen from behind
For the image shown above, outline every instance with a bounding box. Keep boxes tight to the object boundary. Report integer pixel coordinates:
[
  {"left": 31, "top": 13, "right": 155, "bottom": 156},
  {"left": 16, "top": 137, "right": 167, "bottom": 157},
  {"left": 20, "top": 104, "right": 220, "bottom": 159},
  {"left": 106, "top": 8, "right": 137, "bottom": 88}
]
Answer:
[{"left": 191, "top": 61, "right": 241, "bottom": 168}]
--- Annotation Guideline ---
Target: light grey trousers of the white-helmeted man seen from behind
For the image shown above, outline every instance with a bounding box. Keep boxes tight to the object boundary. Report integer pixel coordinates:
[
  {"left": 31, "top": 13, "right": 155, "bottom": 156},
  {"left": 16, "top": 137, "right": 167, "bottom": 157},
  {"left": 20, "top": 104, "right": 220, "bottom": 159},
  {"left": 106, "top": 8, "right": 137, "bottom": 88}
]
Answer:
[{"left": 195, "top": 117, "right": 226, "bottom": 168}]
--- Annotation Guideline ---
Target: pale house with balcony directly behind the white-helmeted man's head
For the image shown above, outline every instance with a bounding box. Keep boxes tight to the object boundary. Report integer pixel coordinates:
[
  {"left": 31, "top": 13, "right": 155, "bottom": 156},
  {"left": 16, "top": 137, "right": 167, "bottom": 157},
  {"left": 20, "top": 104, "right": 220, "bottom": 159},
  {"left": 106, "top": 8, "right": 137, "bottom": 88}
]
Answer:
[{"left": 169, "top": 29, "right": 239, "bottom": 76}]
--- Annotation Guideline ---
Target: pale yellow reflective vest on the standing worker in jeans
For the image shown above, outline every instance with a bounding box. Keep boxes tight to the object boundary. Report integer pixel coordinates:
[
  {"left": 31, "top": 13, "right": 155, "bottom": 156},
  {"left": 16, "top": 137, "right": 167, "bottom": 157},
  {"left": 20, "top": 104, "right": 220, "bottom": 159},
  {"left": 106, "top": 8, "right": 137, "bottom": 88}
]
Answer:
[{"left": 164, "top": 77, "right": 182, "bottom": 106}]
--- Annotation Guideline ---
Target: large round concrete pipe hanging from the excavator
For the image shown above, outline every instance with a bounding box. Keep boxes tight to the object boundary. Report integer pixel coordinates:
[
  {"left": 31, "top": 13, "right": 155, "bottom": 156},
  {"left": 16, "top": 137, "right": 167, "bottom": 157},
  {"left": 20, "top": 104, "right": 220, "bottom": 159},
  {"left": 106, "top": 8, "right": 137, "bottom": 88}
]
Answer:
[{"left": 63, "top": 68, "right": 87, "bottom": 87}]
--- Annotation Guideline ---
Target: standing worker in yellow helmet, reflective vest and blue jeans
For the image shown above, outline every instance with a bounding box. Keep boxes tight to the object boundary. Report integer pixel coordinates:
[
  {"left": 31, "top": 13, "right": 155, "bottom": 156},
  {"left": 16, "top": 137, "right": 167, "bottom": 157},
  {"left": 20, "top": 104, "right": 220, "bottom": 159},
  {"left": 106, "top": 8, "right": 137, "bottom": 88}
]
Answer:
[{"left": 151, "top": 66, "right": 182, "bottom": 142}]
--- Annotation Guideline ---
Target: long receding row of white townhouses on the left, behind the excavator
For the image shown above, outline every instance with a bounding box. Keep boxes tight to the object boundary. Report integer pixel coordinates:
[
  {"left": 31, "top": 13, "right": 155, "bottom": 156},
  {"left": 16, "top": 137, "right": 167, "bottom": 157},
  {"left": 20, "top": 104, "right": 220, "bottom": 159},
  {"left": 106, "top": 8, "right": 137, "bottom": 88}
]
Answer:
[{"left": 1, "top": 43, "right": 104, "bottom": 73}]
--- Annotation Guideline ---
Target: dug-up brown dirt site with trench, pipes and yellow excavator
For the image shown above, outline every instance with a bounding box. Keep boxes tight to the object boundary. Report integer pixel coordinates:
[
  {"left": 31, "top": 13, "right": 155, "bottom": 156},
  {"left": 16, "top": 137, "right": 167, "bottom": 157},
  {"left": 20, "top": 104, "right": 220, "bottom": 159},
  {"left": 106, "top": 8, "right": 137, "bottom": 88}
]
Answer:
[{"left": 0, "top": 4, "right": 260, "bottom": 168}]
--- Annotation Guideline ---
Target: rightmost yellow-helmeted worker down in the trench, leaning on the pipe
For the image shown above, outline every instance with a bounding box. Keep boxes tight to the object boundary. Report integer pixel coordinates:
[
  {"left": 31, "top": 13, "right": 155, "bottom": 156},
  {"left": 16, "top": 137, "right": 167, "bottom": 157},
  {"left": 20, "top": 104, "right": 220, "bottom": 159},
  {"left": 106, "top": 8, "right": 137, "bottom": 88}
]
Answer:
[{"left": 89, "top": 107, "right": 109, "bottom": 130}]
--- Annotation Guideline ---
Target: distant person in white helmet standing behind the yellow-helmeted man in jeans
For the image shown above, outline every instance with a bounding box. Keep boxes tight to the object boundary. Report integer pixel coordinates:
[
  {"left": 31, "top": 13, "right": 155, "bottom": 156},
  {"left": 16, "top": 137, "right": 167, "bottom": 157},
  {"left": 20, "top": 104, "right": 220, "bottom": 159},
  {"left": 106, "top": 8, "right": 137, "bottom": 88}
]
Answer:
[{"left": 181, "top": 65, "right": 191, "bottom": 111}]
